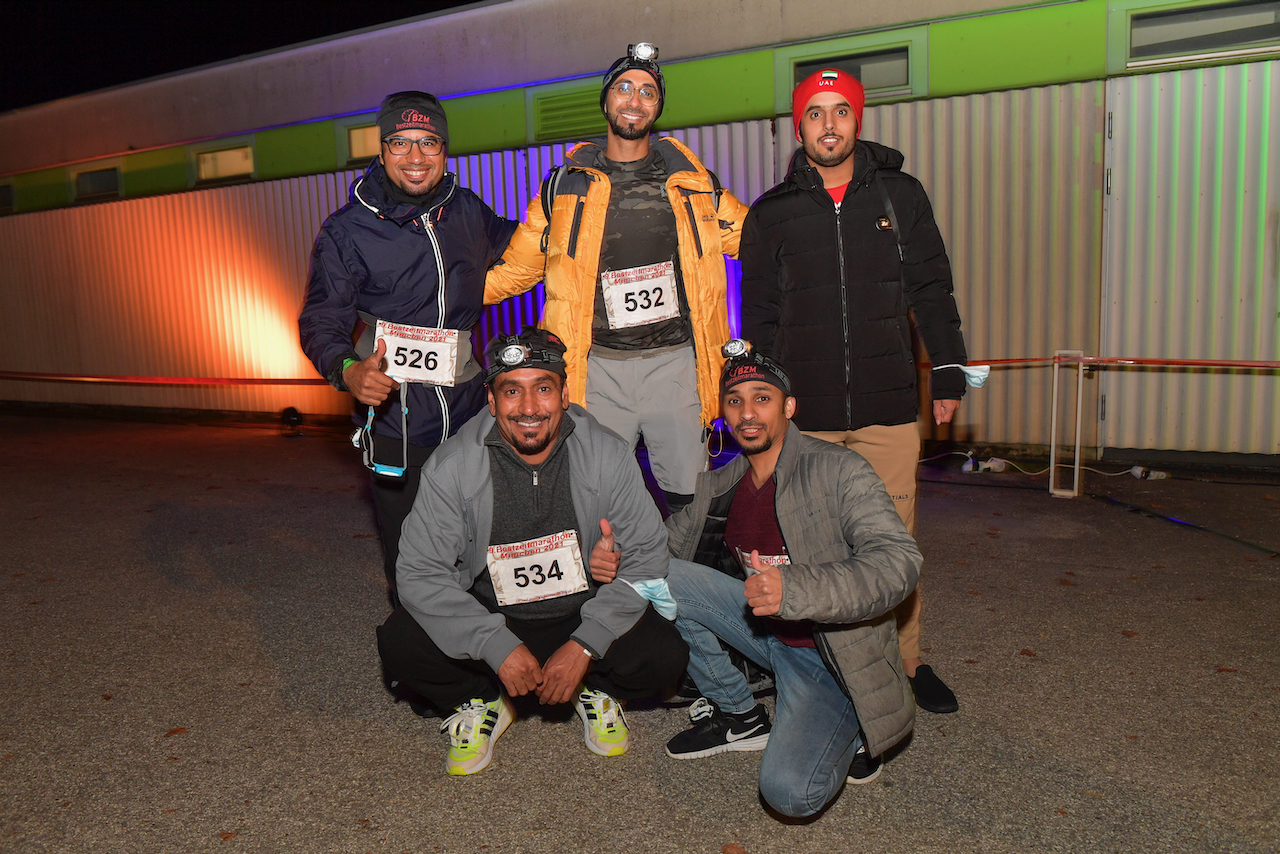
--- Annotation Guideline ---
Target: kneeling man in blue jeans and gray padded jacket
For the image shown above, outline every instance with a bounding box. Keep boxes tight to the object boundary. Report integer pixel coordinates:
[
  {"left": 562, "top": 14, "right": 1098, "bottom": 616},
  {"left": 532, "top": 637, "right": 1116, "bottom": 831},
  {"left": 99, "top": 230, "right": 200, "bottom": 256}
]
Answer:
[{"left": 667, "top": 342, "right": 923, "bottom": 817}]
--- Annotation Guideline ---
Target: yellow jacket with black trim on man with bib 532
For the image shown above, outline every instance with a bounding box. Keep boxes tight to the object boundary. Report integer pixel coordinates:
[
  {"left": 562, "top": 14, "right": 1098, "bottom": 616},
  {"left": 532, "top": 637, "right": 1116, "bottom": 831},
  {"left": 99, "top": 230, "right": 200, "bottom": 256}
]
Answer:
[{"left": 484, "top": 137, "right": 748, "bottom": 426}]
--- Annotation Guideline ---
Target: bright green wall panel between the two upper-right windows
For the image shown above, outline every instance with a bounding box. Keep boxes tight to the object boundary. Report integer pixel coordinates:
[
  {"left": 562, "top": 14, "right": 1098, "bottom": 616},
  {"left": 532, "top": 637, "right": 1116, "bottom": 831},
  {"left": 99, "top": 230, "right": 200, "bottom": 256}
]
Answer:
[{"left": 929, "top": 0, "right": 1107, "bottom": 97}]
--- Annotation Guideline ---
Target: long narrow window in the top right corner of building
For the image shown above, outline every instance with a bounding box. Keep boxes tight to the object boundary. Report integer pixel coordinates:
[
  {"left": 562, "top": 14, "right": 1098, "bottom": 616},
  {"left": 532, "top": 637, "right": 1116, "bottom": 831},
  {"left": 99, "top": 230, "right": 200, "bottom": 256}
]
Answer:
[{"left": 1128, "top": 1, "right": 1280, "bottom": 68}]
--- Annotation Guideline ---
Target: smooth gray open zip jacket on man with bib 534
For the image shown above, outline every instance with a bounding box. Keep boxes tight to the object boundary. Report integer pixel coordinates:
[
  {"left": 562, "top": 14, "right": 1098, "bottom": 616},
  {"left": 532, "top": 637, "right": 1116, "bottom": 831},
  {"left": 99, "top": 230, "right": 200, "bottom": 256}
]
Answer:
[{"left": 396, "top": 403, "right": 668, "bottom": 671}]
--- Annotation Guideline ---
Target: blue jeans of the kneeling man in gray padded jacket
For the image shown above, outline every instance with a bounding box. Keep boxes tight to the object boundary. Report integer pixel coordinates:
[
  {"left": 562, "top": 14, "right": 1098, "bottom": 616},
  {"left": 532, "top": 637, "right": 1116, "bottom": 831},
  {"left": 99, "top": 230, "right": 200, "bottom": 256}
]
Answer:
[{"left": 667, "top": 560, "right": 863, "bottom": 817}]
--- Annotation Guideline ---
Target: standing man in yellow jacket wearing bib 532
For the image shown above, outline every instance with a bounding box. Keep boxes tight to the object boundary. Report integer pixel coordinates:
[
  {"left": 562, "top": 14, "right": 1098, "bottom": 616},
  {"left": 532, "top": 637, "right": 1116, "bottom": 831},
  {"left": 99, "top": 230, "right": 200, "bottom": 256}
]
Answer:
[{"left": 484, "top": 42, "right": 748, "bottom": 511}]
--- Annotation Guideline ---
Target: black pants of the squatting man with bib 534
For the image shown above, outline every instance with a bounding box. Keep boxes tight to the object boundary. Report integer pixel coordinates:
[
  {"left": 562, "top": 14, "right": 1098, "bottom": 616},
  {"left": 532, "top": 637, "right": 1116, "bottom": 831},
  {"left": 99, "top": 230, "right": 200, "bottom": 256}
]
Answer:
[{"left": 378, "top": 606, "right": 689, "bottom": 714}]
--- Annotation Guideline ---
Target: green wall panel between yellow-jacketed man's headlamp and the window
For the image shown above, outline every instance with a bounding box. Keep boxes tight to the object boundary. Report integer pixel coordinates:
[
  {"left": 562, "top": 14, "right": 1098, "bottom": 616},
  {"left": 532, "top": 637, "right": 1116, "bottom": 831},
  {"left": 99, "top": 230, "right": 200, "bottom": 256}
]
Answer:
[{"left": 655, "top": 50, "right": 773, "bottom": 128}]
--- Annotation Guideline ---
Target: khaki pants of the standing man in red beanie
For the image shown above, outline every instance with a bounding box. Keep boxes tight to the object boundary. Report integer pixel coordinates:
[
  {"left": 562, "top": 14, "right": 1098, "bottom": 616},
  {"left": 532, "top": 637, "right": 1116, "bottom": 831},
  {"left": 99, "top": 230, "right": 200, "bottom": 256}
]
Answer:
[{"left": 804, "top": 421, "right": 920, "bottom": 661}]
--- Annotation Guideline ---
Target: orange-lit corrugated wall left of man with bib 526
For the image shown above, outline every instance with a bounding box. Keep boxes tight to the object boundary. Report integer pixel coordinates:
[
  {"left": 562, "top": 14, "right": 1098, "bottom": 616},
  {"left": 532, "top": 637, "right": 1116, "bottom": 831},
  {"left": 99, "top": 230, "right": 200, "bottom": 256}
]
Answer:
[{"left": 0, "top": 173, "right": 366, "bottom": 414}]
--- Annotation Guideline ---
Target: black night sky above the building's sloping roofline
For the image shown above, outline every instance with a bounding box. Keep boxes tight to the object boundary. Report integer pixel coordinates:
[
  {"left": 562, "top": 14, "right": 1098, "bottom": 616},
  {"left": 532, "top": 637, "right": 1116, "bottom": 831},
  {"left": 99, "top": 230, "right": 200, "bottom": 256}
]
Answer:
[{"left": 0, "top": 0, "right": 481, "bottom": 113}]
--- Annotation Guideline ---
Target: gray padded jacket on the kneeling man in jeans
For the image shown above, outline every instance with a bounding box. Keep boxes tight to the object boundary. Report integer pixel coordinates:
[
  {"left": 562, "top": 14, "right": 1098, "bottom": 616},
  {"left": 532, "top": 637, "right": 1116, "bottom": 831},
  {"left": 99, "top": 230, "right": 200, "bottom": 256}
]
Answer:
[{"left": 667, "top": 424, "right": 924, "bottom": 755}]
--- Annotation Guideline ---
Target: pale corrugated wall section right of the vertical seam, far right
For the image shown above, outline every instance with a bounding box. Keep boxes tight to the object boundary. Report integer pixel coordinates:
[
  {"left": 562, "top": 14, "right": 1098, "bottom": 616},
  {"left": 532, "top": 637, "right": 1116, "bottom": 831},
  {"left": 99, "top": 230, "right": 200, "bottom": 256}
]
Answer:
[{"left": 1101, "top": 61, "right": 1280, "bottom": 455}]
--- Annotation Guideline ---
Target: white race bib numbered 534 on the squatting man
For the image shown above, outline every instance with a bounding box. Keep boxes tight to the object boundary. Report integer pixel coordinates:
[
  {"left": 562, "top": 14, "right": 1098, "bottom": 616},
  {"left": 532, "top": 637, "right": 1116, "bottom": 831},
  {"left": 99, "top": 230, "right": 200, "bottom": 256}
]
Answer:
[{"left": 488, "top": 531, "right": 588, "bottom": 606}]
